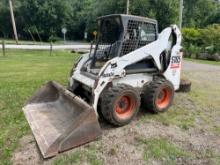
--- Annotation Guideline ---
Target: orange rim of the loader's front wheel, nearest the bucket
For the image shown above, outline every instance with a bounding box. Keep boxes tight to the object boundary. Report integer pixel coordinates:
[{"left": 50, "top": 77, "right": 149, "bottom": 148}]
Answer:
[{"left": 115, "top": 95, "right": 136, "bottom": 119}]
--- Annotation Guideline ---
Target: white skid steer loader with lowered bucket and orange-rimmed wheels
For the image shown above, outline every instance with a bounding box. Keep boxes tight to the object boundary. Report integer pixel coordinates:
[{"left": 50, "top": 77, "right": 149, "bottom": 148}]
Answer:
[{"left": 23, "top": 15, "right": 182, "bottom": 158}]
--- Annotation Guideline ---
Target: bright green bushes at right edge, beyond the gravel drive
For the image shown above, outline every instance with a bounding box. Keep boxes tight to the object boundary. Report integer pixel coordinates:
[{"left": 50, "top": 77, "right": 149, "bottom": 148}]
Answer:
[{"left": 182, "top": 24, "right": 220, "bottom": 60}]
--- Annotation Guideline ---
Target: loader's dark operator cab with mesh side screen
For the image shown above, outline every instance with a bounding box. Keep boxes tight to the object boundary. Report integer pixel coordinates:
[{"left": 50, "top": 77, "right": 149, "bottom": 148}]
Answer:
[{"left": 85, "top": 14, "right": 158, "bottom": 75}]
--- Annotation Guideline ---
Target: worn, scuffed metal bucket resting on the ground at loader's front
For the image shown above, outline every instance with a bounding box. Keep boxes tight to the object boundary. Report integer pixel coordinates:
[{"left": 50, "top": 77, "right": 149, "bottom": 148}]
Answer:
[{"left": 23, "top": 81, "right": 101, "bottom": 158}]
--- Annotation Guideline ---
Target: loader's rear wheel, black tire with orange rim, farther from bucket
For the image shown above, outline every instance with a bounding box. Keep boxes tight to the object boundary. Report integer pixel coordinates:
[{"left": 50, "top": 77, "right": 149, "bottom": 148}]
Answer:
[{"left": 142, "top": 78, "right": 174, "bottom": 113}]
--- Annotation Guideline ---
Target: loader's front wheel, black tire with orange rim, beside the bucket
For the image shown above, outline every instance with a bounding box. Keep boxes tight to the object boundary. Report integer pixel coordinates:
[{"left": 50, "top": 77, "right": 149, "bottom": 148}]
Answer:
[{"left": 101, "top": 84, "right": 141, "bottom": 126}]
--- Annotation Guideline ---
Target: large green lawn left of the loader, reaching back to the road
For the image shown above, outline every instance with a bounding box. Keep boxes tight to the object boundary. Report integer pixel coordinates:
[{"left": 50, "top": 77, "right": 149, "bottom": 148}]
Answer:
[{"left": 0, "top": 50, "right": 78, "bottom": 164}]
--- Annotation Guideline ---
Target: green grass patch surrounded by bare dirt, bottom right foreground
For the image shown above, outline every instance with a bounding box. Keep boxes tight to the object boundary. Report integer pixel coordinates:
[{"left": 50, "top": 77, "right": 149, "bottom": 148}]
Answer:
[{"left": 137, "top": 138, "right": 190, "bottom": 164}]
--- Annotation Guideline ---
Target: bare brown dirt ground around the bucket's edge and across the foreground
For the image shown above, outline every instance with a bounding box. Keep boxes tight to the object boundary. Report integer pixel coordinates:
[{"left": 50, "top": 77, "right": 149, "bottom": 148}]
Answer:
[{"left": 12, "top": 121, "right": 220, "bottom": 165}]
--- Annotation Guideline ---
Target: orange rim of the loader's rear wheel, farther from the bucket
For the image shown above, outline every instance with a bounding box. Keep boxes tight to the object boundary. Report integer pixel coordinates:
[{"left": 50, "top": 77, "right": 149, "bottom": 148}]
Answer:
[{"left": 156, "top": 87, "right": 171, "bottom": 109}]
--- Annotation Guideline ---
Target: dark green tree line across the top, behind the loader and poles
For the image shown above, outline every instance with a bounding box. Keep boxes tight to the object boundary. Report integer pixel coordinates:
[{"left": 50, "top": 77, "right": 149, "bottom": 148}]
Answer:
[{"left": 0, "top": 0, "right": 220, "bottom": 41}]
